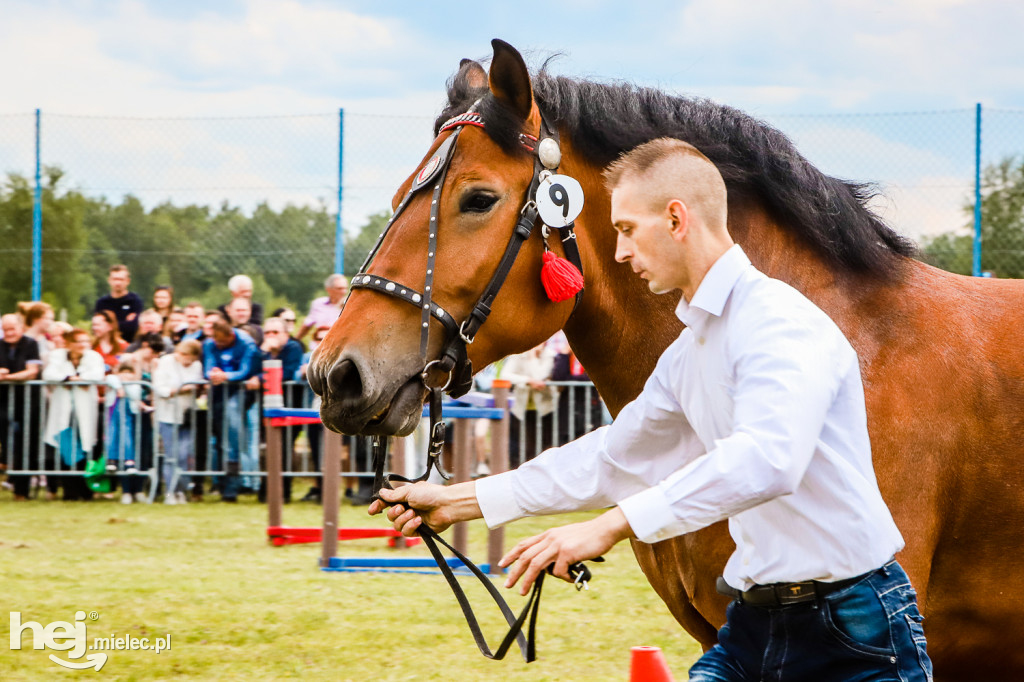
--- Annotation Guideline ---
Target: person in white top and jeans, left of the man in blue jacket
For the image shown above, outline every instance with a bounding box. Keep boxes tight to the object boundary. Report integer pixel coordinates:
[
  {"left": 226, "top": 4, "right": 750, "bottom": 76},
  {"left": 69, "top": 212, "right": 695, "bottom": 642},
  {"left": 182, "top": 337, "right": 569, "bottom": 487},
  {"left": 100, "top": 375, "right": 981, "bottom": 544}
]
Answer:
[{"left": 153, "top": 339, "right": 204, "bottom": 505}]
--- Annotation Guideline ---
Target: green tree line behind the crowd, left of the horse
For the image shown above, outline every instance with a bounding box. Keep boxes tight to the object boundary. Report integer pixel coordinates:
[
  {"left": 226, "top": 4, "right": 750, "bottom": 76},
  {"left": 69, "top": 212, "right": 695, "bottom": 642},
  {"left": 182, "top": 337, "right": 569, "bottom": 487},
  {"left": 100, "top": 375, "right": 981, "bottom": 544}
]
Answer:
[{"left": 0, "top": 167, "right": 388, "bottom": 323}]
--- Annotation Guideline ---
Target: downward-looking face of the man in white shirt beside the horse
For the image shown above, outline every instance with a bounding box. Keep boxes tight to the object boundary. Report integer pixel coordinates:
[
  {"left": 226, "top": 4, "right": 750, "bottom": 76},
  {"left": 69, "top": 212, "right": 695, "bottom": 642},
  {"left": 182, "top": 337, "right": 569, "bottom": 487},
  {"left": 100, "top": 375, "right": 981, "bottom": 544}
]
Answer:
[{"left": 611, "top": 180, "right": 682, "bottom": 294}]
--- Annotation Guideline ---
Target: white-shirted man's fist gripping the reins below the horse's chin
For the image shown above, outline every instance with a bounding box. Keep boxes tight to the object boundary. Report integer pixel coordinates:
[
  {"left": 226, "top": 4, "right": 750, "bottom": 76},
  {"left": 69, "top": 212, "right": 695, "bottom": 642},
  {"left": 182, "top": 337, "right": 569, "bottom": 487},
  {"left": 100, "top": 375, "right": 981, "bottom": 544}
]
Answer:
[{"left": 368, "top": 481, "right": 480, "bottom": 538}]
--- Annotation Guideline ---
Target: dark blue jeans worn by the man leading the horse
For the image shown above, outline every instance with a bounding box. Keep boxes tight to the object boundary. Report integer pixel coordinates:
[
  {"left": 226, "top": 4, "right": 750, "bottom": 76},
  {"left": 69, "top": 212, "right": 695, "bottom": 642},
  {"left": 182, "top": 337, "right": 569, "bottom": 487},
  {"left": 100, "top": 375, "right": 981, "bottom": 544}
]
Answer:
[{"left": 690, "top": 561, "right": 932, "bottom": 682}]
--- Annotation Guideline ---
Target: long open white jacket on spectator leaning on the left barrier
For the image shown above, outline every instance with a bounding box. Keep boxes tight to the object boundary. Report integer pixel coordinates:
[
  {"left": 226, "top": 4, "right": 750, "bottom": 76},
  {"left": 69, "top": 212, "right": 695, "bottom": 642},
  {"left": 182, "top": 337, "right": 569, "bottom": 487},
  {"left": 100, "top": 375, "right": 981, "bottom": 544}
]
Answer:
[{"left": 43, "top": 348, "right": 104, "bottom": 452}]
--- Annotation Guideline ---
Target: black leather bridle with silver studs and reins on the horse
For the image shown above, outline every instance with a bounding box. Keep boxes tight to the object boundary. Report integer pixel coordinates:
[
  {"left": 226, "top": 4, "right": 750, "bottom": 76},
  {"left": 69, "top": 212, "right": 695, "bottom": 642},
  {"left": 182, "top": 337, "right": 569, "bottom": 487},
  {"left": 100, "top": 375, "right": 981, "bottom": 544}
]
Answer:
[{"left": 349, "top": 104, "right": 590, "bottom": 663}]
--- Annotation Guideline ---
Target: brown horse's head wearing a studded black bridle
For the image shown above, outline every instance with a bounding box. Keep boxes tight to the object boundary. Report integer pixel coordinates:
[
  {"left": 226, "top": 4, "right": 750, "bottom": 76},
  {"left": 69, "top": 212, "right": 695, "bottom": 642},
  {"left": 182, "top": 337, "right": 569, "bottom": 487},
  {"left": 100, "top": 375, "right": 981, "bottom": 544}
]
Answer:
[{"left": 309, "top": 40, "right": 573, "bottom": 435}]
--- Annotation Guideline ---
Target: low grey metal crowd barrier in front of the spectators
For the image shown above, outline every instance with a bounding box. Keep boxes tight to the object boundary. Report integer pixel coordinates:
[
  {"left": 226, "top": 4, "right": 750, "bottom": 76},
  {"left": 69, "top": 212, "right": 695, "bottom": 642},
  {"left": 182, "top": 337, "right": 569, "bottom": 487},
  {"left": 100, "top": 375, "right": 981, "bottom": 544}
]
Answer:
[{"left": 0, "top": 381, "right": 610, "bottom": 502}]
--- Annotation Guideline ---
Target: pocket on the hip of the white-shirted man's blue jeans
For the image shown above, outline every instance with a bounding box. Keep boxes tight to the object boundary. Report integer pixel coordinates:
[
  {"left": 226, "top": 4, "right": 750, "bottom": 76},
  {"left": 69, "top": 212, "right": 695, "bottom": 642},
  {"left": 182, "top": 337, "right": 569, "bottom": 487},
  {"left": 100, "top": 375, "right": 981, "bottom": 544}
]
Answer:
[{"left": 820, "top": 588, "right": 895, "bottom": 663}]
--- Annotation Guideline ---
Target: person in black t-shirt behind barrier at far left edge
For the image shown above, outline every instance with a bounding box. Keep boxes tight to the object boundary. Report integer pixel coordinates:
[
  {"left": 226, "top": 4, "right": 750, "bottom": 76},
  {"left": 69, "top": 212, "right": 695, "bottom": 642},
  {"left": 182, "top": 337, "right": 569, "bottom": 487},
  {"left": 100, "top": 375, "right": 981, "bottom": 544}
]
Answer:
[{"left": 0, "top": 314, "right": 41, "bottom": 500}]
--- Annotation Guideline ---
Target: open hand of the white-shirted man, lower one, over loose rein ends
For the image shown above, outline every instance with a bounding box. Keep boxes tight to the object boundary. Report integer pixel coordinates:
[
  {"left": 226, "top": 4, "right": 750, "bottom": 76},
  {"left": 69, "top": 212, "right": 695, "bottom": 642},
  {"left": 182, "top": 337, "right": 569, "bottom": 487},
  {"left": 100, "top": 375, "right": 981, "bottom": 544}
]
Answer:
[{"left": 498, "top": 507, "right": 633, "bottom": 595}]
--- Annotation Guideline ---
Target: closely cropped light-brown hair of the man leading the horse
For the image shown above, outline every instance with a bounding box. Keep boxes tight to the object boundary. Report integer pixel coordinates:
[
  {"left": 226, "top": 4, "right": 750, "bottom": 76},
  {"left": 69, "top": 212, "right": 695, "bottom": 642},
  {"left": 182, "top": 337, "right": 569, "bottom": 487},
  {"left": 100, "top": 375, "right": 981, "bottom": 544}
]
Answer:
[{"left": 604, "top": 137, "right": 727, "bottom": 227}]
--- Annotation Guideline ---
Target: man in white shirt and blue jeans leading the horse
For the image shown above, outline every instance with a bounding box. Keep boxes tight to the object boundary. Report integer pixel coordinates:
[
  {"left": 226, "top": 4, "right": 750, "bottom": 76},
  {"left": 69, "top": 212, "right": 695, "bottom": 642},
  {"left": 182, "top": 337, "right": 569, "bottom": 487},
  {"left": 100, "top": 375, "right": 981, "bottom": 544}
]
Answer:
[{"left": 370, "top": 138, "right": 931, "bottom": 682}]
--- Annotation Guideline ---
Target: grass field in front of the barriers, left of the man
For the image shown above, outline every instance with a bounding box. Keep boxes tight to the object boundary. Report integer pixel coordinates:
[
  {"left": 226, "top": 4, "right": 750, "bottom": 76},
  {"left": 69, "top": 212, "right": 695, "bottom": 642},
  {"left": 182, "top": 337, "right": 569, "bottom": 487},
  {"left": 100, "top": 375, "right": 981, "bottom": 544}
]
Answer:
[{"left": 0, "top": 481, "right": 699, "bottom": 682}]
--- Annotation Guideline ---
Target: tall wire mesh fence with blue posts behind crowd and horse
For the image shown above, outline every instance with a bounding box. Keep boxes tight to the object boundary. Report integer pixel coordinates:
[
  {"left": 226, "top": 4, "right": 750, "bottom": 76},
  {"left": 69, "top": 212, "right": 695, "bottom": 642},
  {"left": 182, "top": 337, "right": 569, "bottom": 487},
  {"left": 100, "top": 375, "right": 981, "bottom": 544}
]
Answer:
[{"left": 0, "top": 106, "right": 1024, "bottom": 319}]
